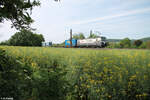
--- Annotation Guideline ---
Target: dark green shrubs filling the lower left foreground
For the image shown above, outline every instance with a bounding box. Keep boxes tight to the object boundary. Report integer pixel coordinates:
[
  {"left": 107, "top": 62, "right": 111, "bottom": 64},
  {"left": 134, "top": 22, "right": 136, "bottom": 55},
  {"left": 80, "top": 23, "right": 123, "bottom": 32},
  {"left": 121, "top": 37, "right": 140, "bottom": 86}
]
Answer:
[{"left": 0, "top": 49, "right": 68, "bottom": 100}]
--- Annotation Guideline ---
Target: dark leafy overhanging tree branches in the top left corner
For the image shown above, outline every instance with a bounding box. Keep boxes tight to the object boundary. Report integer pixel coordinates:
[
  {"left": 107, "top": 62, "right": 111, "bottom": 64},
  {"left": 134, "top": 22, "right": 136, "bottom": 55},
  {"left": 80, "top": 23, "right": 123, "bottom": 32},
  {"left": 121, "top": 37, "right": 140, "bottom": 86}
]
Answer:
[{"left": 0, "top": 0, "right": 40, "bottom": 29}]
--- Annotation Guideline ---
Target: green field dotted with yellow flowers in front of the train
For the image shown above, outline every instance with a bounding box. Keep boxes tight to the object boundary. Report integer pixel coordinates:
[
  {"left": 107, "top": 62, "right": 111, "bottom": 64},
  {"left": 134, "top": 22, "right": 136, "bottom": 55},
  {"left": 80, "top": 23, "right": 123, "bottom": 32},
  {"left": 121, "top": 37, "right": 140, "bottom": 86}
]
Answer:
[{"left": 0, "top": 46, "right": 150, "bottom": 100}]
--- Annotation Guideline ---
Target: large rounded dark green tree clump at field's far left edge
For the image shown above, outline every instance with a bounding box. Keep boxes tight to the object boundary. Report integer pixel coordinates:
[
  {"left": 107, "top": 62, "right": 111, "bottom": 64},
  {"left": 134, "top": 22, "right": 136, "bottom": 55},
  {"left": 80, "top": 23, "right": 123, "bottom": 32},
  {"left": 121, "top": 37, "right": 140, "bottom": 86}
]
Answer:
[{"left": 9, "top": 30, "right": 44, "bottom": 46}]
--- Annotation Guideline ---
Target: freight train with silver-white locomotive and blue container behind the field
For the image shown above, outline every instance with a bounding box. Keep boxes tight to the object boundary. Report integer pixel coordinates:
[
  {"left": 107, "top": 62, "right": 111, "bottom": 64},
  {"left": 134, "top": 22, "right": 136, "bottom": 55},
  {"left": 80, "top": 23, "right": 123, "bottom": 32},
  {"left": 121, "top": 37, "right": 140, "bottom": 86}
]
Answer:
[{"left": 65, "top": 37, "right": 107, "bottom": 48}]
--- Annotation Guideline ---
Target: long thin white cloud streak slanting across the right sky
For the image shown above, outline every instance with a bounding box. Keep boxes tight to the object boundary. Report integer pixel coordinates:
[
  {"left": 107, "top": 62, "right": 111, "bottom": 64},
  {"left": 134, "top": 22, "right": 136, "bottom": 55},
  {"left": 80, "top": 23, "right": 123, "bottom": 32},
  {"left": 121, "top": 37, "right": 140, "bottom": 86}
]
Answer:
[{"left": 69, "top": 8, "right": 150, "bottom": 25}]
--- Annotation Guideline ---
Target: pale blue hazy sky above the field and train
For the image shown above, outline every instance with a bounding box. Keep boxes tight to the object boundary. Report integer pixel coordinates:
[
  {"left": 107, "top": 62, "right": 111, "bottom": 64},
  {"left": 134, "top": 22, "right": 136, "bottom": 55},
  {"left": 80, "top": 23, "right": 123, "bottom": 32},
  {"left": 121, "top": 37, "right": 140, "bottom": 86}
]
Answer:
[{"left": 0, "top": 0, "right": 150, "bottom": 43}]
